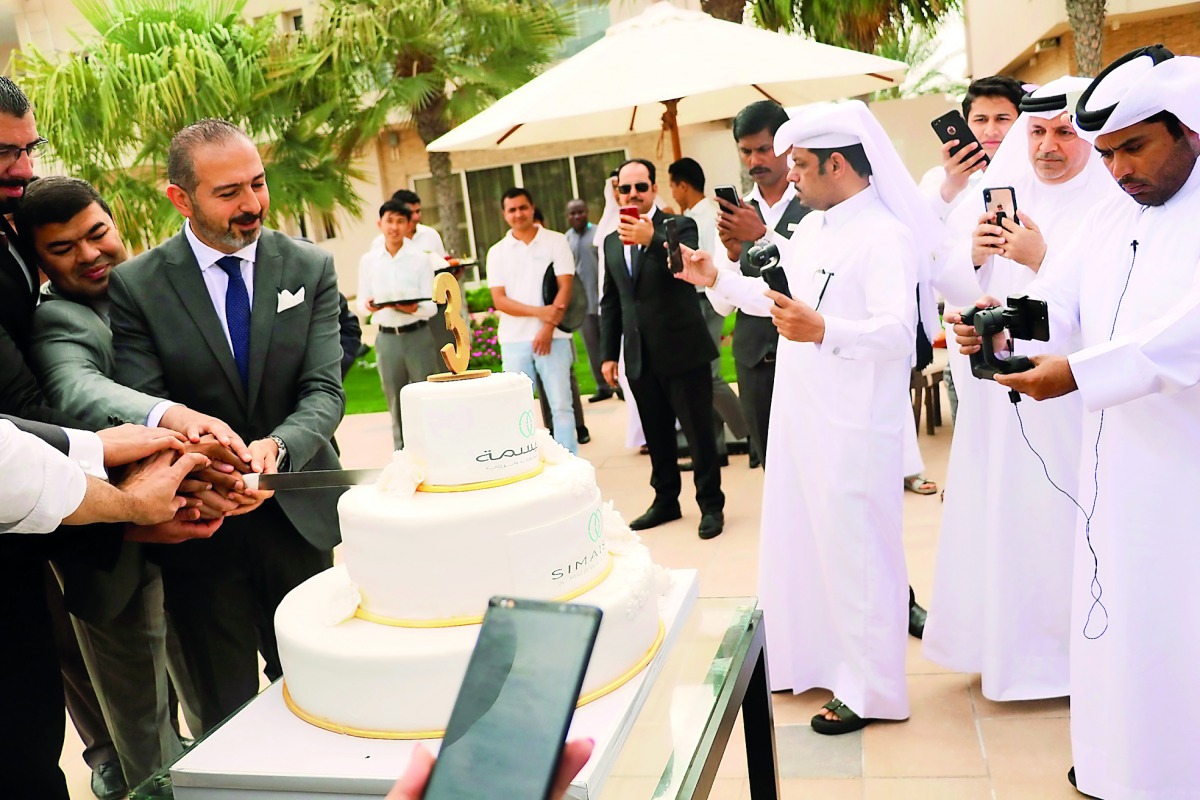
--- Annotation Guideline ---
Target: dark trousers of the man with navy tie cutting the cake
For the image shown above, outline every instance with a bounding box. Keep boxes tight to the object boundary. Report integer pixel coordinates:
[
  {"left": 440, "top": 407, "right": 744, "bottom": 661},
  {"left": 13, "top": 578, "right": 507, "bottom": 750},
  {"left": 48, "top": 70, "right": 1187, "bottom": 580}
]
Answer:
[{"left": 158, "top": 499, "right": 332, "bottom": 736}]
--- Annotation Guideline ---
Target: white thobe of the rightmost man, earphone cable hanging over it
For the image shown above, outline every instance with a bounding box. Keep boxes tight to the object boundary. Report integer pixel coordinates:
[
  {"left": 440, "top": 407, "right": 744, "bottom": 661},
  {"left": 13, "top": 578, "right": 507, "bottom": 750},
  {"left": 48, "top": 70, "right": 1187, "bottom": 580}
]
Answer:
[{"left": 1030, "top": 168, "right": 1200, "bottom": 800}]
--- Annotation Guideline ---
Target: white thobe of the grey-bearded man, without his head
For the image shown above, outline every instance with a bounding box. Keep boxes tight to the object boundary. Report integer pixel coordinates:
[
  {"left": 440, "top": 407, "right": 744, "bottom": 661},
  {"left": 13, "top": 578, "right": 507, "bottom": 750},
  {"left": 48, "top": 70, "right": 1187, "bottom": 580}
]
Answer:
[{"left": 923, "top": 164, "right": 1130, "bottom": 700}]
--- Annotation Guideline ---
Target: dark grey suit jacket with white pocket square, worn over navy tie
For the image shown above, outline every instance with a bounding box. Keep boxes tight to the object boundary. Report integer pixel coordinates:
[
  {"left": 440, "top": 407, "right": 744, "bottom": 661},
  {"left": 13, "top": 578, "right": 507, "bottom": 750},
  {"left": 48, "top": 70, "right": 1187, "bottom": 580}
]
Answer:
[{"left": 109, "top": 225, "right": 346, "bottom": 549}]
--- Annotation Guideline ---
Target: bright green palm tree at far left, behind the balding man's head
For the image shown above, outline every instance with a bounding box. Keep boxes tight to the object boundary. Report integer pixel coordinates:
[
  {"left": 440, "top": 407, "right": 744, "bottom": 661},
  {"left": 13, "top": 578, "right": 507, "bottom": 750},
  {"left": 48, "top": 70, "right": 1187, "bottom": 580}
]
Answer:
[{"left": 14, "top": 0, "right": 359, "bottom": 248}]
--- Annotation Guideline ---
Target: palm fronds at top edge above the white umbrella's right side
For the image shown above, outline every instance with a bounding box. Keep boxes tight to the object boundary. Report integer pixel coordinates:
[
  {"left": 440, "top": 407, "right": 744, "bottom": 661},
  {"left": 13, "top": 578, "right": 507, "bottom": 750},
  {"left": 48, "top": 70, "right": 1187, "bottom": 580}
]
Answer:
[{"left": 738, "top": 0, "right": 959, "bottom": 53}]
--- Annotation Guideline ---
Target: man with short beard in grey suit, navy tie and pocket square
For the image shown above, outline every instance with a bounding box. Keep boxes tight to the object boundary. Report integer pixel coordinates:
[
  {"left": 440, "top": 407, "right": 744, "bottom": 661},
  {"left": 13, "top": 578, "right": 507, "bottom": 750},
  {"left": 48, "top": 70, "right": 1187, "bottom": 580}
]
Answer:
[{"left": 109, "top": 120, "right": 346, "bottom": 730}]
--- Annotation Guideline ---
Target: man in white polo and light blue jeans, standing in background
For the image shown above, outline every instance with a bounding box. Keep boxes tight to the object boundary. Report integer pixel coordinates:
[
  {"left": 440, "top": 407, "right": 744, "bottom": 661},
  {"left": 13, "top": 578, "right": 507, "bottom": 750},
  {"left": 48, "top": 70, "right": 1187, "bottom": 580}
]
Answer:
[{"left": 487, "top": 187, "right": 580, "bottom": 453}]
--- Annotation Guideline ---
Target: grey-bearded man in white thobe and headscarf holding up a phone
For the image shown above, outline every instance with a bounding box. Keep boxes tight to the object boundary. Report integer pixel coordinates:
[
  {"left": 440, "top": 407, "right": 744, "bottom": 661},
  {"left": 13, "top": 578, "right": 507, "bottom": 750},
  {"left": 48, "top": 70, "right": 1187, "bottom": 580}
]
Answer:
[{"left": 923, "top": 77, "right": 1130, "bottom": 700}]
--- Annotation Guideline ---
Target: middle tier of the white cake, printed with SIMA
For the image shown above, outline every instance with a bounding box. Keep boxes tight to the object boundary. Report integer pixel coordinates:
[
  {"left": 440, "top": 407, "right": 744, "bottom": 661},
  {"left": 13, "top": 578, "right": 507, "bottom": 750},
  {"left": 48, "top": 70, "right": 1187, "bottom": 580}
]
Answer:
[{"left": 337, "top": 455, "right": 607, "bottom": 620}]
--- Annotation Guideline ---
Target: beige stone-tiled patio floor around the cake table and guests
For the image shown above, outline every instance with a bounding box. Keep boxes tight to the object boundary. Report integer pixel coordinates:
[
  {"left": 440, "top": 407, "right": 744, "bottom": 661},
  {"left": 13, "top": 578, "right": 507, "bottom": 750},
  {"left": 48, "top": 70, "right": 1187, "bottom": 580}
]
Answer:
[{"left": 62, "top": 379, "right": 1080, "bottom": 800}]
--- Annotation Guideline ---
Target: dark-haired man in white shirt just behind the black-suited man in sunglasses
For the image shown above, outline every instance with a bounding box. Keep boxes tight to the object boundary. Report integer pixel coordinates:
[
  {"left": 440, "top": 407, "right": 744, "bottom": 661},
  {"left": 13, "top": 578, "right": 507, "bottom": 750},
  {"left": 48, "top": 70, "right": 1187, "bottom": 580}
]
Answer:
[{"left": 667, "top": 158, "right": 748, "bottom": 467}]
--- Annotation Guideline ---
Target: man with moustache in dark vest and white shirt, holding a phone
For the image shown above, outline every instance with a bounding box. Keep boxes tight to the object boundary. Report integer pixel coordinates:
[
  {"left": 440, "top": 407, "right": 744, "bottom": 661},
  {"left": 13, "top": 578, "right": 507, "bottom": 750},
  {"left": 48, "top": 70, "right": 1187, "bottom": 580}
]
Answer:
[{"left": 708, "top": 100, "right": 809, "bottom": 465}]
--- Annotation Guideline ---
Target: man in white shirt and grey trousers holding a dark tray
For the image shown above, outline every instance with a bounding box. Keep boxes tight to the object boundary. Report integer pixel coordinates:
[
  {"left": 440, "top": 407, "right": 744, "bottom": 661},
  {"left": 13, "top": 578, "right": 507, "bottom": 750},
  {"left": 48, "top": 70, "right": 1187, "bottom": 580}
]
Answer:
[{"left": 359, "top": 200, "right": 445, "bottom": 450}]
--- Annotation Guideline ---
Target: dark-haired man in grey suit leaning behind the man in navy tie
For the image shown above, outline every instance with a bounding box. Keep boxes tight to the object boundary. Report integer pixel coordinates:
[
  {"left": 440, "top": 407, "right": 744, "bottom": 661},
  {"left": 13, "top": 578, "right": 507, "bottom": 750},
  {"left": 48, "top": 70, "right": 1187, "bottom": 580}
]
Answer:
[{"left": 16, "top": 176, "right": 229, "bottom": 786}]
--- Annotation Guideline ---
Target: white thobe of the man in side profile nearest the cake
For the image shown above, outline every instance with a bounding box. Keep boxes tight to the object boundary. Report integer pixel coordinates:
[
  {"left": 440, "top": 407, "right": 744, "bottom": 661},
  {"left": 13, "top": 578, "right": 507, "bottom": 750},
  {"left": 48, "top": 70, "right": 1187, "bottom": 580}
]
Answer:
[{"left": 714, "top": 186, "right": 917, "bottom": 720}]
